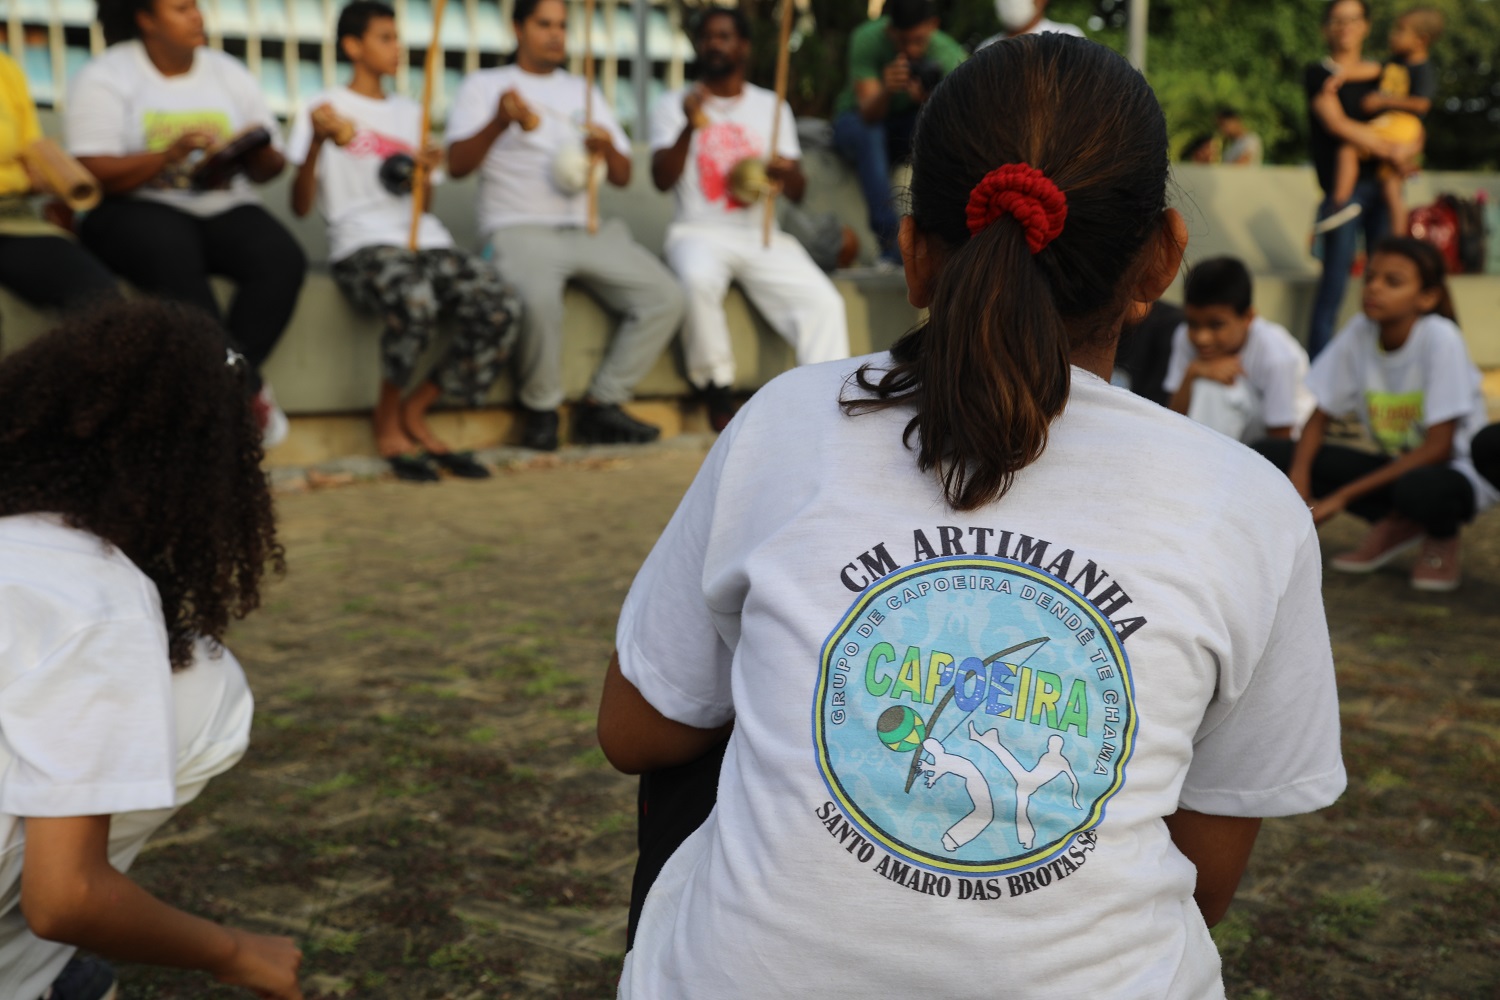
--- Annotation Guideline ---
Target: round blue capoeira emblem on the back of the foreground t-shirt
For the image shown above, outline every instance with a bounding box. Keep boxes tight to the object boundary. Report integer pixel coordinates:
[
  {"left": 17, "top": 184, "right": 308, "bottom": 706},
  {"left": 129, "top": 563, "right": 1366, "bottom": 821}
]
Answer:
[{"left": 813, "top": 556, "right": 1136, "bottom": 876}]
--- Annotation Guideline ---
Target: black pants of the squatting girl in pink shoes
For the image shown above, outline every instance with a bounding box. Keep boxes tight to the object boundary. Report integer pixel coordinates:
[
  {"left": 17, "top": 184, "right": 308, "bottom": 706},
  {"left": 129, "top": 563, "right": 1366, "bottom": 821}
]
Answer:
[{"left": 1256, "top": 441, "right": 1475, "bottom": 538}]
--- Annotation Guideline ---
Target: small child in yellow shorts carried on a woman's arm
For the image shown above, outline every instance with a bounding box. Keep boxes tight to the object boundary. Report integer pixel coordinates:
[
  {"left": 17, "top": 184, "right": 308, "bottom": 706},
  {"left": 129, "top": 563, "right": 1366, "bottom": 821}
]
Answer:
[{"left": 1317, "top": 7, "right": 1443, "bottom": 235}]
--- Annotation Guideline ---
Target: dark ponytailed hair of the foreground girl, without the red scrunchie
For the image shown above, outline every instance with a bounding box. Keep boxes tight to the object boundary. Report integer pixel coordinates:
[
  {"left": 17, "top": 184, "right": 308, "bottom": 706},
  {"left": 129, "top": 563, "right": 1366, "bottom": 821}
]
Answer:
[{"left": 842, "top": 33, "right": 1169, "bottom": 510}]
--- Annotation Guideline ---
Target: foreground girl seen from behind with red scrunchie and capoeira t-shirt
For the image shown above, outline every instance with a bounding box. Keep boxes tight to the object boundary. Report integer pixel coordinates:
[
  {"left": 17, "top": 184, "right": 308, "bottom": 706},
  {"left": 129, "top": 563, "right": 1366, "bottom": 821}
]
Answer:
[{"left": 599, "top": 34, "right": 1344, "bottom": 1000}]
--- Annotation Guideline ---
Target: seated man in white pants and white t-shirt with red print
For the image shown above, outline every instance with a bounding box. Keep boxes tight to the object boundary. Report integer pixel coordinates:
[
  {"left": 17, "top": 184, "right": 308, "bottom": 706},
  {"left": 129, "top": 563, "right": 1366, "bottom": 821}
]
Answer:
[{"left": 651, "top": 7, "right": 849, "bottom": 430}]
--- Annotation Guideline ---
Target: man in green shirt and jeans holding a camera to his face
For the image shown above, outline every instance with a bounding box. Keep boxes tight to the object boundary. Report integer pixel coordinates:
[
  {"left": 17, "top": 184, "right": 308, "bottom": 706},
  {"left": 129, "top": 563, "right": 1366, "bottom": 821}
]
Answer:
[{"left": 834, "top": 0, "right": 968, "bottom": 264}]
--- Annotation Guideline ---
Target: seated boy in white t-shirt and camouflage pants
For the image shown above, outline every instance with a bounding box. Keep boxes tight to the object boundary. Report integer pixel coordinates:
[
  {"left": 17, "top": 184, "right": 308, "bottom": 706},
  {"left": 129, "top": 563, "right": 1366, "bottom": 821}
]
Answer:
[{"left": 290, "top": 0, "right": 521, "bottom": 481}]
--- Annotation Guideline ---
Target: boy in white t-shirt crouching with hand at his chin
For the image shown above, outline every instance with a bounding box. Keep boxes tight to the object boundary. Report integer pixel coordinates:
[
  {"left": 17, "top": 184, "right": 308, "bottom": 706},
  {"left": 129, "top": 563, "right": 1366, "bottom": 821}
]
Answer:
[{"left": 1163, "top": 256, "right": 1317, "bottom": 444}]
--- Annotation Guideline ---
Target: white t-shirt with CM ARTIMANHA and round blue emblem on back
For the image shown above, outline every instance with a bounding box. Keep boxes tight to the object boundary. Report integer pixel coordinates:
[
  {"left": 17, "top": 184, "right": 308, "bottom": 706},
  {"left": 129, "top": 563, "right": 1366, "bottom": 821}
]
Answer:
[{"left": 617, "top": 355, "right": 1346, "bottom": 1000}]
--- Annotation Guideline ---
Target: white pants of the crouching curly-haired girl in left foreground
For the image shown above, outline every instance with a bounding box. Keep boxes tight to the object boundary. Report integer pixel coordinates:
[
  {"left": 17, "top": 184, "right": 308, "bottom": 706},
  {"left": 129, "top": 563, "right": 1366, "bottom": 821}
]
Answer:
[{"left": 0, "top": 643, "right": 255, "bottom": 1000}]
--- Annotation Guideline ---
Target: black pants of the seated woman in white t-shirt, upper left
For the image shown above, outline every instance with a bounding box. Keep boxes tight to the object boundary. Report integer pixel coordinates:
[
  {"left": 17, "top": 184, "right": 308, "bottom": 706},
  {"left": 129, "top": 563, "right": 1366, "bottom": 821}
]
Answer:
[{"left": 80, "top": 198, "right": 308, "bottom": 379}]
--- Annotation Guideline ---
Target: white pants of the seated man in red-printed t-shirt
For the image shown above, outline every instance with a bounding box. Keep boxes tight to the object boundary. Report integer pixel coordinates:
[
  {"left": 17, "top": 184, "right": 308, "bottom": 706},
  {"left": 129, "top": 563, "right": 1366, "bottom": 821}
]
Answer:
[{"left": 665, "top": 225, "right": 849, "bottom": 388}]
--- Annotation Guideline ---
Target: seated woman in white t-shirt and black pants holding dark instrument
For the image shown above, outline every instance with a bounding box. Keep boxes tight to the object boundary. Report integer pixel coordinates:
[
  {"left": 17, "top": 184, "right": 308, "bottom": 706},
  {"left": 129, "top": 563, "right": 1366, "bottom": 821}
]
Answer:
[{"left": 63, "top": 0, "right": 308, "bottom": 445}]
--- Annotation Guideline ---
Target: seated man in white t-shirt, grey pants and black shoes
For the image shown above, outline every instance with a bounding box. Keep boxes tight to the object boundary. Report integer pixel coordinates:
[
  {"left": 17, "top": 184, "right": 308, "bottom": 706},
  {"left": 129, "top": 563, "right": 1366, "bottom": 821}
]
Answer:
[{"left": 447, "top": 0, "right": 683, "bottom": 451}]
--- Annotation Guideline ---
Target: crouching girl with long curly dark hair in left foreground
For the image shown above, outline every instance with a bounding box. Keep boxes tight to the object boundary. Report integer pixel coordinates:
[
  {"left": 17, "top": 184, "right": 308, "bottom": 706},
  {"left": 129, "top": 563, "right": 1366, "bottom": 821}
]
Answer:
[{"left": 0, "top": 301, "right": 302, "bottom": 1000}]
